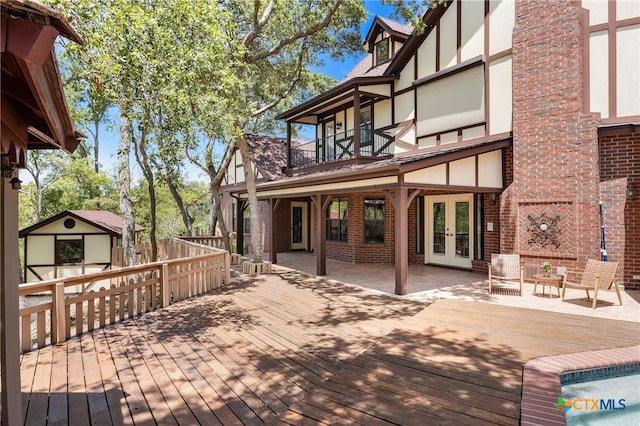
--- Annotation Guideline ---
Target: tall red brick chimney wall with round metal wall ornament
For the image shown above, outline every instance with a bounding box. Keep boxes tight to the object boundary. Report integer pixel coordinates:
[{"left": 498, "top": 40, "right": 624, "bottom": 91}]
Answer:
[{"left": 510, "top": 0, "right": 600, "bottom": 267}]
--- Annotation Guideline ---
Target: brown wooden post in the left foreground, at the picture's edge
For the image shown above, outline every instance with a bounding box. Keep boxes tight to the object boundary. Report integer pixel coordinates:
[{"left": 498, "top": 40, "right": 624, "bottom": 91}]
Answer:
[{"left": 0, "top": 172, "right": 23, "bottom": 425}]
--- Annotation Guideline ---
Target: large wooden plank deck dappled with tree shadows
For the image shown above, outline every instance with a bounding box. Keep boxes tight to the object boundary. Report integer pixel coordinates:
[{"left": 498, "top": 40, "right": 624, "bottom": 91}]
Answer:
[{"left": 22, "top": 268, "right": 640, "bottom": 425}]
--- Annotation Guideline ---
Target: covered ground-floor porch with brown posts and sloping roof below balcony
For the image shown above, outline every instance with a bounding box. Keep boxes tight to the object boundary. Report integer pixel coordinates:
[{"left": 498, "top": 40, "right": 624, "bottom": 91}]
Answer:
[{"left": 234, "top": 136, "right": 511, "bottom": 295}]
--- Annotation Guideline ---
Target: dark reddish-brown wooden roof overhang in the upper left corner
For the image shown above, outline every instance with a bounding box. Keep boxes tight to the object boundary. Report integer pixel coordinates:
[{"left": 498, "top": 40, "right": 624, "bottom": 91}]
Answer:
[{"left": 0, "top": 0, "right": 82, "bottom": 167}]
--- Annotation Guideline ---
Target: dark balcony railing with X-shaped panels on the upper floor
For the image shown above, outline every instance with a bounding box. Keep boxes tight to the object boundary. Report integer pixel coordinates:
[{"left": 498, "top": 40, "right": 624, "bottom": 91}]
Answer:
[{"left": 289, "top": 129, "right": 394, "bottom": 167}]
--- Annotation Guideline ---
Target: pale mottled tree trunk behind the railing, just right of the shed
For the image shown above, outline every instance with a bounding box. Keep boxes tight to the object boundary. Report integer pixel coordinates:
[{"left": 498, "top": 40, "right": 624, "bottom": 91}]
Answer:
[{"left": 118, "top": 113, "right": 137, "bottom": 266}]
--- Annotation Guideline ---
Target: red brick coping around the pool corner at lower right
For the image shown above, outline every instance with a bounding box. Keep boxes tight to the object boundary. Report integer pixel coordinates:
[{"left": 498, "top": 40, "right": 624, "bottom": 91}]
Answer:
[{"left": 520, "top": 345, "right": 640, "bottom": 425}]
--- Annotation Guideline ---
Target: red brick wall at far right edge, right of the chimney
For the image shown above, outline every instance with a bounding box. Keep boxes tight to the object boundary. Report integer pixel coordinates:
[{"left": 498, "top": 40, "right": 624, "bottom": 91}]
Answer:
[{"left": 599, "top": 127, "right": 640, "bottom": 289}]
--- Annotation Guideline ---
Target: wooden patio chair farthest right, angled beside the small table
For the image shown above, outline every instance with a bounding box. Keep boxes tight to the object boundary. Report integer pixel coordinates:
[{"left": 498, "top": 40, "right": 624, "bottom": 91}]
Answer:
[{"left": 561, "top": 259, "right": 622, "bottom": 309}]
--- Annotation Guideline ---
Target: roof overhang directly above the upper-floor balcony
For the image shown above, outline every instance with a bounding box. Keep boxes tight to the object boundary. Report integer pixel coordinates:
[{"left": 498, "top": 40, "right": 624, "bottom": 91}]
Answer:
[{"left": 276, "top": 75, "right": 399, "bottom": 124}]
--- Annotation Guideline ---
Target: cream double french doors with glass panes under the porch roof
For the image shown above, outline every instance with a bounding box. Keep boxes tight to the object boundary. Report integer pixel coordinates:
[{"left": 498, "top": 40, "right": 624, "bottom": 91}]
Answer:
[{"left": 425, "top": 194, "right": 473, "bottom": 268}]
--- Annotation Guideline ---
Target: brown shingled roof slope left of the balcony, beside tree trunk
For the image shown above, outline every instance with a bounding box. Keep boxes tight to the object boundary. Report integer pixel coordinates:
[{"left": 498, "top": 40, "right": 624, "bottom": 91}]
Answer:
[{"left": 245, "top": 134, "right": 287, "bottom": 180}]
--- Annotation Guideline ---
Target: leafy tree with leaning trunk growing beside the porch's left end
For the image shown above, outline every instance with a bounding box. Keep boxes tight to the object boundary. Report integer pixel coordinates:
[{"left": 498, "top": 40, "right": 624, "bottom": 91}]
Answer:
[{"left": 221, "top": 0, "right": 366, "bottom": 263}]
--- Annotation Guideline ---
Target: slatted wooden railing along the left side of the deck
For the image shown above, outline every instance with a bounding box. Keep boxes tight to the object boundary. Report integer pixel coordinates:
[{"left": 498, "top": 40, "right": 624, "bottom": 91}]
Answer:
[{"left": 19, "top": 239, "right": 231, "bottom": 352}]
